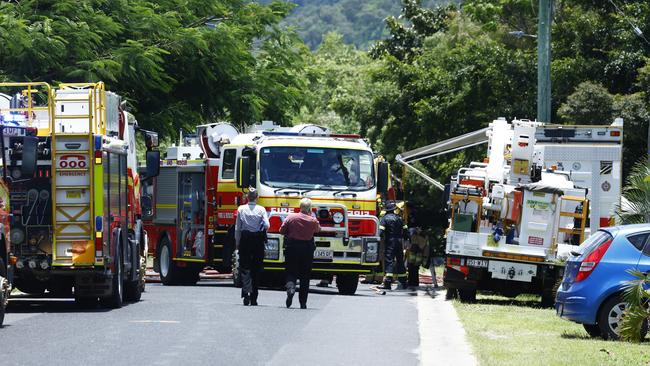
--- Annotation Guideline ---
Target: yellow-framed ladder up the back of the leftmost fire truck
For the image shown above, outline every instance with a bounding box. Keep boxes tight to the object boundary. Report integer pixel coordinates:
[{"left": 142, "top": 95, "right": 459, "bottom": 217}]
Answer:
[{"left": 51, "top": 83, "right": 106, "bottom": 266}]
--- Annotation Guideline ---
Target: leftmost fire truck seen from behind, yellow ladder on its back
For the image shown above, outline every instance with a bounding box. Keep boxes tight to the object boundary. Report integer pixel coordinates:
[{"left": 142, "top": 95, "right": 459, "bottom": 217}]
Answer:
[{"left": 0, "top": 82, "right": 160, "bottom": 307}]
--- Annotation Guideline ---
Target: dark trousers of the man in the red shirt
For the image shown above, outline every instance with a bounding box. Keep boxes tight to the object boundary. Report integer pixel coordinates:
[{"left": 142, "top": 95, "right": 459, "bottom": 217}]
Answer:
[{"left": 284, "top": 240, "right": 315, "bottom": 305}]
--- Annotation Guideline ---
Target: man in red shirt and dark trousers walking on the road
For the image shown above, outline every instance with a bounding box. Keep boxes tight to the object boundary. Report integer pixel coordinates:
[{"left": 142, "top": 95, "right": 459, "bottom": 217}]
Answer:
[{"left": 280, "top": 198, "right": 320, "bottom": 309}]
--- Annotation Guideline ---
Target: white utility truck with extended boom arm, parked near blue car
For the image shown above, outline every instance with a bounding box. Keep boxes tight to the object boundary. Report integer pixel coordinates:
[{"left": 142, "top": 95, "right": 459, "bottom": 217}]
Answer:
[{"left": 397, "top": 119, "right": 623, "bottom": 305}]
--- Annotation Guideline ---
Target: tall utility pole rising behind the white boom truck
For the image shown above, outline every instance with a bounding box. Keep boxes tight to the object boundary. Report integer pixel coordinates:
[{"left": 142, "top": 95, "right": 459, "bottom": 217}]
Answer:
[{"left": 537, "top": 0, "right": 553, "bottom": 122}]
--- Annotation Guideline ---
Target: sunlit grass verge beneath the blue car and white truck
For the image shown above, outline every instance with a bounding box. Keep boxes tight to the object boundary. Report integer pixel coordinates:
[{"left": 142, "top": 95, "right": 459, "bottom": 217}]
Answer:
[{"left": 454, "top": 296, "right": 650, "bottom": 366}]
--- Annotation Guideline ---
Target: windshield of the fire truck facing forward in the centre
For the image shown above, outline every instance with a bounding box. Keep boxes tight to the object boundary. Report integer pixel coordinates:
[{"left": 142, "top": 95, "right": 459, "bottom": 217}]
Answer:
[{"left": 260, "top": 146, "right": 375, "bottom": 191}]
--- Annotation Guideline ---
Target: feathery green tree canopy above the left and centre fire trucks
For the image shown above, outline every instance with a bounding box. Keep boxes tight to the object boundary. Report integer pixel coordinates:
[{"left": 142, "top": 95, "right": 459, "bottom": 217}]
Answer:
[{"left": 0, "top": 0, "right": 306, "bottom": 134}]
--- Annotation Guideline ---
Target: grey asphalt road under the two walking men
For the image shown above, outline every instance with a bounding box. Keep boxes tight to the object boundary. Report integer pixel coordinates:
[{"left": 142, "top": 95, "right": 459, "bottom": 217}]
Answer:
[{"left": 0, "top": 280, "right": 421, "bottom": 366}]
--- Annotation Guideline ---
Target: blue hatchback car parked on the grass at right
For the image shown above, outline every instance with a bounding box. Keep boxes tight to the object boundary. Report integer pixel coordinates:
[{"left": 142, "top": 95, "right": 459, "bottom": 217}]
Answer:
[{"left": 555, "top": 224, "right": 650, "bottom": 339}]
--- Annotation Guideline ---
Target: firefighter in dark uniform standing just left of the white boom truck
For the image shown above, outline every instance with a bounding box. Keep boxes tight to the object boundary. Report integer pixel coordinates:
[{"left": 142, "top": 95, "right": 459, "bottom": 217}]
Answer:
[{"left": 379, "top": 201, "right": 408, "bottom": 290}]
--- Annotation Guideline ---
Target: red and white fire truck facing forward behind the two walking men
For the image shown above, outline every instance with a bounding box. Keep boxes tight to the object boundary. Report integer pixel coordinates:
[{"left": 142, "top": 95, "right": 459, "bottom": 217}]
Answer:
[{"left": 143, "top": 121, "right": 389, "bottom": 294}]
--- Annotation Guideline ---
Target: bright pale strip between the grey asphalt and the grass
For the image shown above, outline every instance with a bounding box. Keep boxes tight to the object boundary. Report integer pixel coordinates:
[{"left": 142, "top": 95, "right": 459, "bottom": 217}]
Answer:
[{"left": 417, "top": 292, "right": 478, "bottom": 366}]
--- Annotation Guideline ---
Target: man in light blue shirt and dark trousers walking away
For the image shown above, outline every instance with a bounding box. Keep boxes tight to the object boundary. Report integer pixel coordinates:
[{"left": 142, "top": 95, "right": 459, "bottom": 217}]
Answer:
[{"left": 235, "top": 188, "right": 269, "bottom": 306}]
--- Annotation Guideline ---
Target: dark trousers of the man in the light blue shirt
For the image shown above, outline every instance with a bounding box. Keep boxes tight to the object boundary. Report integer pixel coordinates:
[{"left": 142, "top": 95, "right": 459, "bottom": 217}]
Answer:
[{"left": 239, "top": 231, "right": 264, "bottom": 301}]
